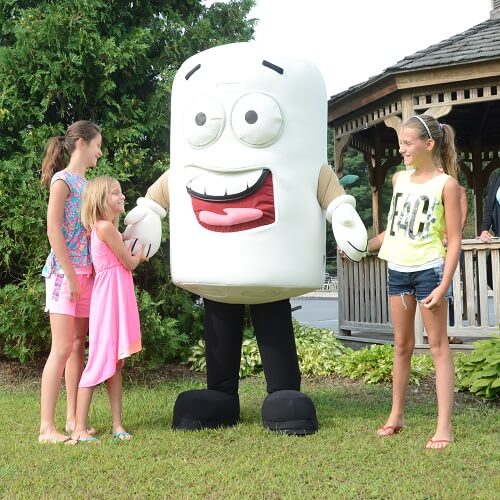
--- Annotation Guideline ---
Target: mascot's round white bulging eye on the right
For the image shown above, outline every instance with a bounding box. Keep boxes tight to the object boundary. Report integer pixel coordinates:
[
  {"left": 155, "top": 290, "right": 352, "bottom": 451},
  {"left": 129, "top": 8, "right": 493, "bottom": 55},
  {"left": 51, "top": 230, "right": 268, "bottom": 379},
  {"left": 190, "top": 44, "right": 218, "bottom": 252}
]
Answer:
[{"left": 231, "top": 92, "right": 283, "bottom": 147}]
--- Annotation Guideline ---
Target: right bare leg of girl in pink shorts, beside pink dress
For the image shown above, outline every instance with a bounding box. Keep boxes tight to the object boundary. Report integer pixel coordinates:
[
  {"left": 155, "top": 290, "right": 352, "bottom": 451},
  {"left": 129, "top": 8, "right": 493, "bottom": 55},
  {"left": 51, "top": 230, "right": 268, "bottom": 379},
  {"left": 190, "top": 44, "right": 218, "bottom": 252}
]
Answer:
[{"left": 64, "top": 318, "right": 89, "bottom": 432}]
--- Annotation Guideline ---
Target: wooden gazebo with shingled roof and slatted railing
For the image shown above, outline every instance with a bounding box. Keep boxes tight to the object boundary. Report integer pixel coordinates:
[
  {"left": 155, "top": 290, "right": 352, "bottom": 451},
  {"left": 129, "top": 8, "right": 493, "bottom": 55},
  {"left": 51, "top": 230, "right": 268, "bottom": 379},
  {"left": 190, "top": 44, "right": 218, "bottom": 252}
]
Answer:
[{"left": 328, "top": 0, "right": 500, "bottom": 345}]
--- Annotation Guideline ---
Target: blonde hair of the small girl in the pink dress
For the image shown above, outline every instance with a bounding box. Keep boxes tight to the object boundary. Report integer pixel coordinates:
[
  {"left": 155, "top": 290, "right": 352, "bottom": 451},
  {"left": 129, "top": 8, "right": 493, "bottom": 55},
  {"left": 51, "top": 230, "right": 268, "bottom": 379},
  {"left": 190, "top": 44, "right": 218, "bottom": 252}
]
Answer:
[{"left": 81, "top": 175, "right": 120, "bottom": 230}]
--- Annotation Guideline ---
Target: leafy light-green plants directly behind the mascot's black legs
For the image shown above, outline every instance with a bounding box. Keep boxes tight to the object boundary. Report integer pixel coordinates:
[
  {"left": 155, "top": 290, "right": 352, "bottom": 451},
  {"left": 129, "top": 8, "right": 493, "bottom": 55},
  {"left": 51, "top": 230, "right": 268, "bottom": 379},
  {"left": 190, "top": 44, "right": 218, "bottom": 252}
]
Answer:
[{"left": 186, "top": 321, "right": 349, "bottom": 378}]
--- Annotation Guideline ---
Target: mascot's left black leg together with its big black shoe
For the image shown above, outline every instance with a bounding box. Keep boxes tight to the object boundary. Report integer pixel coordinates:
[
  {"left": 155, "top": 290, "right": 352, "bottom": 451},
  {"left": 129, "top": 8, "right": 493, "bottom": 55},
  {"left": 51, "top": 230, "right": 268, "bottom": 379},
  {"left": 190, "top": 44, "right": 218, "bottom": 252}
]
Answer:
[{"left": 172, "top": 299, "right": 245, "bottom": 430}]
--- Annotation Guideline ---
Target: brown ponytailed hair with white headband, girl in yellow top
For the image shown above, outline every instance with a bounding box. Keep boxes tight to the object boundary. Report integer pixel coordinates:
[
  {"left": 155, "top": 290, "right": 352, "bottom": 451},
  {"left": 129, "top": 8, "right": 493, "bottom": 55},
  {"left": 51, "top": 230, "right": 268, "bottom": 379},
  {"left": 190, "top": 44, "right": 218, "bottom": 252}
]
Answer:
[{"left": 403, "top": 115, "right": 459, "bottom": 179}]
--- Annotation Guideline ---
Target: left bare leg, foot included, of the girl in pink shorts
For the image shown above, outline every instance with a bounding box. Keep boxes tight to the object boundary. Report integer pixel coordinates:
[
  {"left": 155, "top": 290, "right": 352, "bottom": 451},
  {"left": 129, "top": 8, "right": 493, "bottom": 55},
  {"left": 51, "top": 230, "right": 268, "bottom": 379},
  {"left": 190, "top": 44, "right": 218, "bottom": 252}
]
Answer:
[{"left": 39, "top": 314, "right": 75, "bottom": 442}]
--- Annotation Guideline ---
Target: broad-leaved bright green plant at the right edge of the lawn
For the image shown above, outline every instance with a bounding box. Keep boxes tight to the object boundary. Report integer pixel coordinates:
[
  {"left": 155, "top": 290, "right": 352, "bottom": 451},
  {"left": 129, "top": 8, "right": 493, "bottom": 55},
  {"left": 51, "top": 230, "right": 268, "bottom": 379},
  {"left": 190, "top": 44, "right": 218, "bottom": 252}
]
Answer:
[{"left": 455, "top": 335, "right": 500, "bottom": 399}]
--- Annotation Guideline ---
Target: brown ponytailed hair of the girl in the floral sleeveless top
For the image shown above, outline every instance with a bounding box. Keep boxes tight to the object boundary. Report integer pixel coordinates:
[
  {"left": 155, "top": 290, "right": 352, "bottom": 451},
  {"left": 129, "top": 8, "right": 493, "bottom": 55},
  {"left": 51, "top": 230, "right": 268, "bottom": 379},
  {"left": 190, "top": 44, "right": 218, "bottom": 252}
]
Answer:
[{"left": 42, "top": 120, "right": 101, "bottom": 188}]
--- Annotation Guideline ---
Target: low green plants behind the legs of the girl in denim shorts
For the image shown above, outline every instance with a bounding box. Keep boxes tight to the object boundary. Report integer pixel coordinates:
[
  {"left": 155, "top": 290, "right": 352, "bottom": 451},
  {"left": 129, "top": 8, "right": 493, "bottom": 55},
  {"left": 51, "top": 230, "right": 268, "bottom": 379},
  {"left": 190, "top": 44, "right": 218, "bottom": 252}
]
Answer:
[{"left": 337, "top": 345, "right": 433, "bottom": 385}]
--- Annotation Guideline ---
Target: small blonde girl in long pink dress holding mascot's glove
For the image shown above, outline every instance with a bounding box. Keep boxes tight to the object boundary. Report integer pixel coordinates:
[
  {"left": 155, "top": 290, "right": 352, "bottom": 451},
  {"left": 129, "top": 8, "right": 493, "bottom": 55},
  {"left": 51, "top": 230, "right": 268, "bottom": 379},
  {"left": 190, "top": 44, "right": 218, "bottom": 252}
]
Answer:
[{"left": 72, "top": 176, "right": 146, "bottom": 442}]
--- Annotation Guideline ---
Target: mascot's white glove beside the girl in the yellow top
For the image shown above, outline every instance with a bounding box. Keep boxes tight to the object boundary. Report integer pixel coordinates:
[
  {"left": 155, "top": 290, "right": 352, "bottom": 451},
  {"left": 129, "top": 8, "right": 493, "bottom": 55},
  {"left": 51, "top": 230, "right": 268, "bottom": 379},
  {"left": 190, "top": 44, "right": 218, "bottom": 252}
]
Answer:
[{"left": 326, "top": 194, "right": 368, "bottom": 262}]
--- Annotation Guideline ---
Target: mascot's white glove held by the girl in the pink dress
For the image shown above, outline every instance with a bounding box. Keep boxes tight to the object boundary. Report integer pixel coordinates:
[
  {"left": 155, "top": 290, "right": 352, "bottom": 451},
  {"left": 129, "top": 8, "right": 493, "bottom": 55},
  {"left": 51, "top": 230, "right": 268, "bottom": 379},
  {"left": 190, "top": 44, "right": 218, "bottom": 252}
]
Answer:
[{"left": 123, "top": 198, "right": 167, "bottom": 257}]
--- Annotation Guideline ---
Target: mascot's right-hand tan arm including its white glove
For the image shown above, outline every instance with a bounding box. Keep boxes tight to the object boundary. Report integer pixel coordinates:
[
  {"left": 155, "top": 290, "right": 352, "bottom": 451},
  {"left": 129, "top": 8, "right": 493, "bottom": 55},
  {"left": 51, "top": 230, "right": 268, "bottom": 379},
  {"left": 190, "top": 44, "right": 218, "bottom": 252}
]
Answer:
[{"left": 318, "top": 165, "right": 368, "bottom": 262}]
